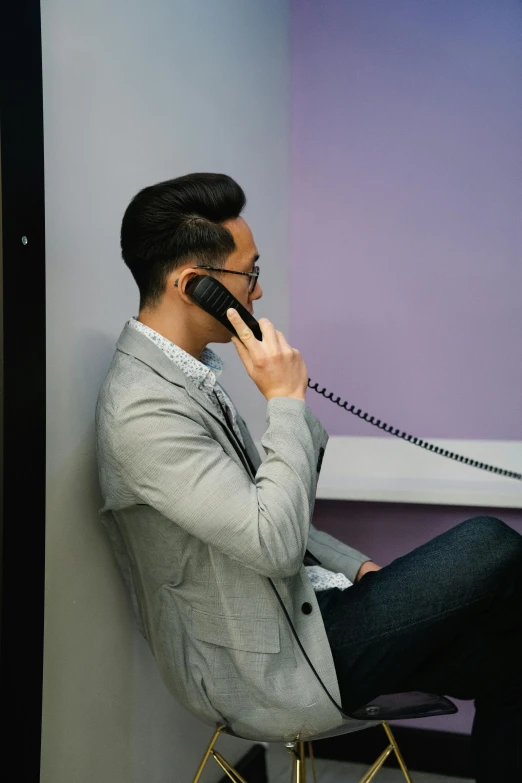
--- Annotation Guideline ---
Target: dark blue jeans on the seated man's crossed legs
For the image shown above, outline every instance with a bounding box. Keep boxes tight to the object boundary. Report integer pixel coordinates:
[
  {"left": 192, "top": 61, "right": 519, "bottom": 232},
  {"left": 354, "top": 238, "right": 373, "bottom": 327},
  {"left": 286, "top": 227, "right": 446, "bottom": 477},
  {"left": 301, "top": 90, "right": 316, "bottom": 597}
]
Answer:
[{"left": 317, "top": 517, "right": 522, "bottom": 783}]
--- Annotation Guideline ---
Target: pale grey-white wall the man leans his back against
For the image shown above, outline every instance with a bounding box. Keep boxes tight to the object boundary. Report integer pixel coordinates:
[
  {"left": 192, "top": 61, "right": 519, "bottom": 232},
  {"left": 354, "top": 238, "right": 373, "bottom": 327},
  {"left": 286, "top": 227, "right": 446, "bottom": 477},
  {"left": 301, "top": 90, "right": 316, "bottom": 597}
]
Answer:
[{"left": 42, "top": 0, "right": 289, "bottom": 783}]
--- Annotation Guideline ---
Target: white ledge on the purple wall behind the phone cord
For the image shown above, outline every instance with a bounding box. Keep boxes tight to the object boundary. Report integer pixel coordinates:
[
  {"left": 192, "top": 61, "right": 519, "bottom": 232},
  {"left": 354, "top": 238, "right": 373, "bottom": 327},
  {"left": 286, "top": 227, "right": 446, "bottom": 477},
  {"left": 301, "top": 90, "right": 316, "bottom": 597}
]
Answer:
[{"left": 256, "top": 435, "right": 522, "bottom": 509}]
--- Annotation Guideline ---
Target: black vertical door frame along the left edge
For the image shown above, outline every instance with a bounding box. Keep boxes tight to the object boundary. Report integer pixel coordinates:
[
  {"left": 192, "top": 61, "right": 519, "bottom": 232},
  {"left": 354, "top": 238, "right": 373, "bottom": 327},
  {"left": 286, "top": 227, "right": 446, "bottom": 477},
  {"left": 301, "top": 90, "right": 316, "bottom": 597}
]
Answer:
[{"left": 0, "top": 0, "right": 46, "bottom": 783}]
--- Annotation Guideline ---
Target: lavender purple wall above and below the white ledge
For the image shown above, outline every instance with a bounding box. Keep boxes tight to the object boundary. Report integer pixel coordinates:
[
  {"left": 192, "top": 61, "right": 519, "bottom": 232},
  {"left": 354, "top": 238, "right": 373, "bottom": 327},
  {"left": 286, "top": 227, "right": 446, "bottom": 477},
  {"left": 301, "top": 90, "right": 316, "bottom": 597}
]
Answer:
[{"left": 290, "top": 0, "right": 522, "bottom": 732}]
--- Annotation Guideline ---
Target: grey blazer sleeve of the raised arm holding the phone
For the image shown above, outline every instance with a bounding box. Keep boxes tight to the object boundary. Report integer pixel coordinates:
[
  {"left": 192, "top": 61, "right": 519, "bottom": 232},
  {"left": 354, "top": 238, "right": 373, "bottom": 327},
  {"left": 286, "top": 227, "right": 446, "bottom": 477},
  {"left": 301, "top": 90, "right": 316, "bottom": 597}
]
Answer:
[{"left": 108, "top": 393, "right": 328, "bottom": 577}]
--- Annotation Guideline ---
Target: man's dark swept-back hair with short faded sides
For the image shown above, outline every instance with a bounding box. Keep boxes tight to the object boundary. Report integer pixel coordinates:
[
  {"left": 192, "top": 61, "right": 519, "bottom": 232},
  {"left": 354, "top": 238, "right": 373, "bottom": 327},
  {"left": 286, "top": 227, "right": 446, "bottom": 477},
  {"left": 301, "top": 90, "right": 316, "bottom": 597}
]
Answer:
[{"left": 121, "top": 174, "right": 246, "bottom": 310}]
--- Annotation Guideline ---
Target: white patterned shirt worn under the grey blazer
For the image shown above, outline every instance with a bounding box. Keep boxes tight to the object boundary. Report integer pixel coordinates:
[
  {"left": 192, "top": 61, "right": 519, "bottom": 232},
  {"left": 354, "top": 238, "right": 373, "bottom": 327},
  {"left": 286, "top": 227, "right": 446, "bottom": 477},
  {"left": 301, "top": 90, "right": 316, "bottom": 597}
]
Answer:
[{"left": 126, "top": 317, "right": 352, "bottom": 592}]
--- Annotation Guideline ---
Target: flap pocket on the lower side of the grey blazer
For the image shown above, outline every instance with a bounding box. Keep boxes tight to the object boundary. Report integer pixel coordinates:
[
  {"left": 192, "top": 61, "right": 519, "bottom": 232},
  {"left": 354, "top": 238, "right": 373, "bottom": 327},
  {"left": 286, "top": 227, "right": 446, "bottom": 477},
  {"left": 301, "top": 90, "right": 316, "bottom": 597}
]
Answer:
[{"left": 192, "top": 609, "right": 281, "bottom": 653}]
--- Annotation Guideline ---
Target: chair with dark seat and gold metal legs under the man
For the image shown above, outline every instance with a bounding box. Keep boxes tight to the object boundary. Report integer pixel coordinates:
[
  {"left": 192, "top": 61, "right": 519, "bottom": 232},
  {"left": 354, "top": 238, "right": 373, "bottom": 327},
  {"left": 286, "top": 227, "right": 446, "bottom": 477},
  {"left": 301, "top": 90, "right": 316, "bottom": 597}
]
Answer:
[{"left": 193, "top": 691, "right": 458, "bottom": 783}]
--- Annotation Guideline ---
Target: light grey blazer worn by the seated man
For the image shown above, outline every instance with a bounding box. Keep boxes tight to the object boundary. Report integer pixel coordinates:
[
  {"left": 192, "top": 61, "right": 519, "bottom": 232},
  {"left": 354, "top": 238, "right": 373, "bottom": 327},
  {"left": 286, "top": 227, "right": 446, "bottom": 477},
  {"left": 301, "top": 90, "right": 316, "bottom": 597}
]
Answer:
[{"left": 96, "top": 326, "right": 375, "bottom": 740}]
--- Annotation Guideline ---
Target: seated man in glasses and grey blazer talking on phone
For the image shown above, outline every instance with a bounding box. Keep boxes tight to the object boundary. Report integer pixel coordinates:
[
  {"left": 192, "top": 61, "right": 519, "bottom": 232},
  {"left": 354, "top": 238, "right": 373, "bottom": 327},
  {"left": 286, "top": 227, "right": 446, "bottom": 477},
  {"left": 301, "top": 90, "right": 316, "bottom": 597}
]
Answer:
[{"left": 96, "top": 174, "right": 522, "bottom": 783}]
